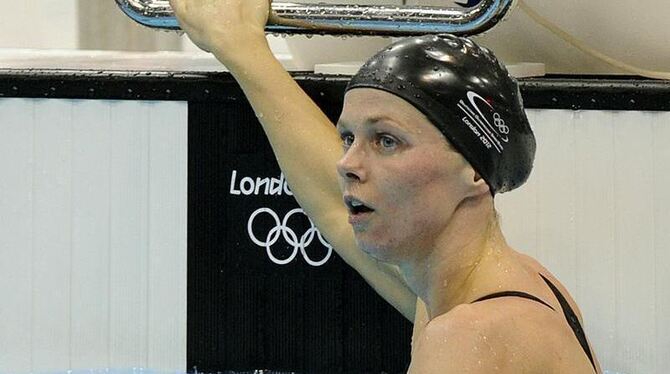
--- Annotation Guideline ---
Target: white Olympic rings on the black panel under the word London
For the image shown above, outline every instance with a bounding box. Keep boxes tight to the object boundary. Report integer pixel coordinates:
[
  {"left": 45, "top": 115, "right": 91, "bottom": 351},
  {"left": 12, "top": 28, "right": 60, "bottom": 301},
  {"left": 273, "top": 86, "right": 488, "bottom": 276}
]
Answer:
[{"left": 247, "top": 208, "right": 333, "bottom": 266}]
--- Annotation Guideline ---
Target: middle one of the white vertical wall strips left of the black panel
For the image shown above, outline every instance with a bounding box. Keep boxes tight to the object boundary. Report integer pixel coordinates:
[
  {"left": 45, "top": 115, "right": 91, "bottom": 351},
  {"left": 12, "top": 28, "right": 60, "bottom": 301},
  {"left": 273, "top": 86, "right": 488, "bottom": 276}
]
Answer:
[{"left": 71, "top": 101, "right": 112, "bottom": 368}]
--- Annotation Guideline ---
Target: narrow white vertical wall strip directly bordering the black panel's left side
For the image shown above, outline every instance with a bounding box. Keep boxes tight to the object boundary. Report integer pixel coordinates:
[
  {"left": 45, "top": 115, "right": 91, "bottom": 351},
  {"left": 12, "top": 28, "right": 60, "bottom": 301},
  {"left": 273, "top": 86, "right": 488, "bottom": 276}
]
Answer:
[{"left": 147, "top": 103, "right": 188, "bottom": 370}]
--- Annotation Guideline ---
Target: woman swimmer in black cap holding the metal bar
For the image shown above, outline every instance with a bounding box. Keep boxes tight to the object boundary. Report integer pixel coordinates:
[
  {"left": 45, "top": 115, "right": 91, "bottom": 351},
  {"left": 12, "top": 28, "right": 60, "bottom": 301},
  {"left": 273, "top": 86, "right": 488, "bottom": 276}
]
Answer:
[{"left": 170, "top": 0, "right": 601, "bottom": 374}]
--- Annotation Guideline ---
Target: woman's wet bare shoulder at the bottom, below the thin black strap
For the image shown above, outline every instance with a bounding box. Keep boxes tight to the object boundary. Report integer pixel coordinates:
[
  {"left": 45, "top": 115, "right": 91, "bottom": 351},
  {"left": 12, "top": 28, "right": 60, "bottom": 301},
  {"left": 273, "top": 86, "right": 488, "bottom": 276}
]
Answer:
[{"left": 410, "top": 298, "right": 564, "bottom": 373}]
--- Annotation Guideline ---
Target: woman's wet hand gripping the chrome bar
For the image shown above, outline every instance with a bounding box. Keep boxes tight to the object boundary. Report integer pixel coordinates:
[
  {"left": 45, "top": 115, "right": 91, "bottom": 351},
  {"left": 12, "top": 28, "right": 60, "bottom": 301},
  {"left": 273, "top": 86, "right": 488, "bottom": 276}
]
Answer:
[{"left": 170, "top": 0, "right": 271, "bottom": 63}]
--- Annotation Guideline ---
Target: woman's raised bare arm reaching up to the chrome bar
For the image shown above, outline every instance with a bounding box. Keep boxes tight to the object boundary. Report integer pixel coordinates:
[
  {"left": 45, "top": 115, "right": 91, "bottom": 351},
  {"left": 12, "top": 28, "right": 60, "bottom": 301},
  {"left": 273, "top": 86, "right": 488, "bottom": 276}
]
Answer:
[{"left": 170, "top": 0, "right": 416, "bottom": 321}]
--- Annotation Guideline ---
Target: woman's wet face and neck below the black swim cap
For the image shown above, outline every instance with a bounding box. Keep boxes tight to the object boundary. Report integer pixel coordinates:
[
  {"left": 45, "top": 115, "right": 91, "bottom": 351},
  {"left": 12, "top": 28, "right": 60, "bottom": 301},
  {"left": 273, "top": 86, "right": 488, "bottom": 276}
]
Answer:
[{"left": 337, "top": 84, "right": 505, "bottom": 318}]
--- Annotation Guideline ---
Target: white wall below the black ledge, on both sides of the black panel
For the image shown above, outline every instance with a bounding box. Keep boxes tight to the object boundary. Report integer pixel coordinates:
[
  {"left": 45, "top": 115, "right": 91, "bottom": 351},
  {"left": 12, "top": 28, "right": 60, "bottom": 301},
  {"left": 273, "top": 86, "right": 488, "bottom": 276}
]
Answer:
[{"left": 0, "top": 99, "right": 670, "bottom": 374}]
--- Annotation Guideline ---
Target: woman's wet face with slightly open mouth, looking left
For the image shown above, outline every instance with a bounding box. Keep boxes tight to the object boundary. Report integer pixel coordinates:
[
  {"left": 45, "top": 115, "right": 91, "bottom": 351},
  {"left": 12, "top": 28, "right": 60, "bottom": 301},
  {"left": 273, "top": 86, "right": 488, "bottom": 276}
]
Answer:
[{"left": 337, "top": 88, "right": 474, "bottom": 263}]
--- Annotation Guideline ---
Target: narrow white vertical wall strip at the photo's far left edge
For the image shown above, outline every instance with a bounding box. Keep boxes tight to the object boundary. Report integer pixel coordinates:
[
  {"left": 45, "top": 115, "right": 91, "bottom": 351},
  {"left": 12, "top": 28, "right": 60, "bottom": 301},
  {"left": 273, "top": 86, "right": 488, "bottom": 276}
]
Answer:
[{"left": 0, "top": 99, "right": 34, "bottom": 371}]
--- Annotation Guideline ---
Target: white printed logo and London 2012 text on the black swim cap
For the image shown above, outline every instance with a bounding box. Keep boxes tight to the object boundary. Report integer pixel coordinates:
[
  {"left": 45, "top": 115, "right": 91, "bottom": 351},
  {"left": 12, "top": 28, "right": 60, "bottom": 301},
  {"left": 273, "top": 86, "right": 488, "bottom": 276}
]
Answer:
[{"left": 458, "top": 91, "right": 509, "bottom": 153}]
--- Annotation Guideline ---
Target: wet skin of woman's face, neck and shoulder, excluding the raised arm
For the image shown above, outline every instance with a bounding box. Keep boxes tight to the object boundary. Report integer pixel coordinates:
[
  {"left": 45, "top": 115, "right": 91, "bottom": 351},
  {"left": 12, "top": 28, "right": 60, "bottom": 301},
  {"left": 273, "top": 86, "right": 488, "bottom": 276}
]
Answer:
[{"left": 337, "top": 88, "right": 604, "bottom": 374}]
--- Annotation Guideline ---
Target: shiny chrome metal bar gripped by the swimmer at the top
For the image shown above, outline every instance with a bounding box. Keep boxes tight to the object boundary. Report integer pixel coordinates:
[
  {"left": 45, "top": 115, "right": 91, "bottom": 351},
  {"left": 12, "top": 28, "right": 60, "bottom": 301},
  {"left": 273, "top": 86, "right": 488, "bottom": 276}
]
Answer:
[{"left": 115, "top": 0, "right": 516, "bottom": 36}]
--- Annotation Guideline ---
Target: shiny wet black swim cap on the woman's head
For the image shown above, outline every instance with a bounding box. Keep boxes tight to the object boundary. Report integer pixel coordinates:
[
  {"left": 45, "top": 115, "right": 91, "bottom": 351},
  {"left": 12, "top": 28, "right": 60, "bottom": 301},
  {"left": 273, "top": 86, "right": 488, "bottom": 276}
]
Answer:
[{"left": 346, "top": 34, "right": 535, "bottom": 195}]
